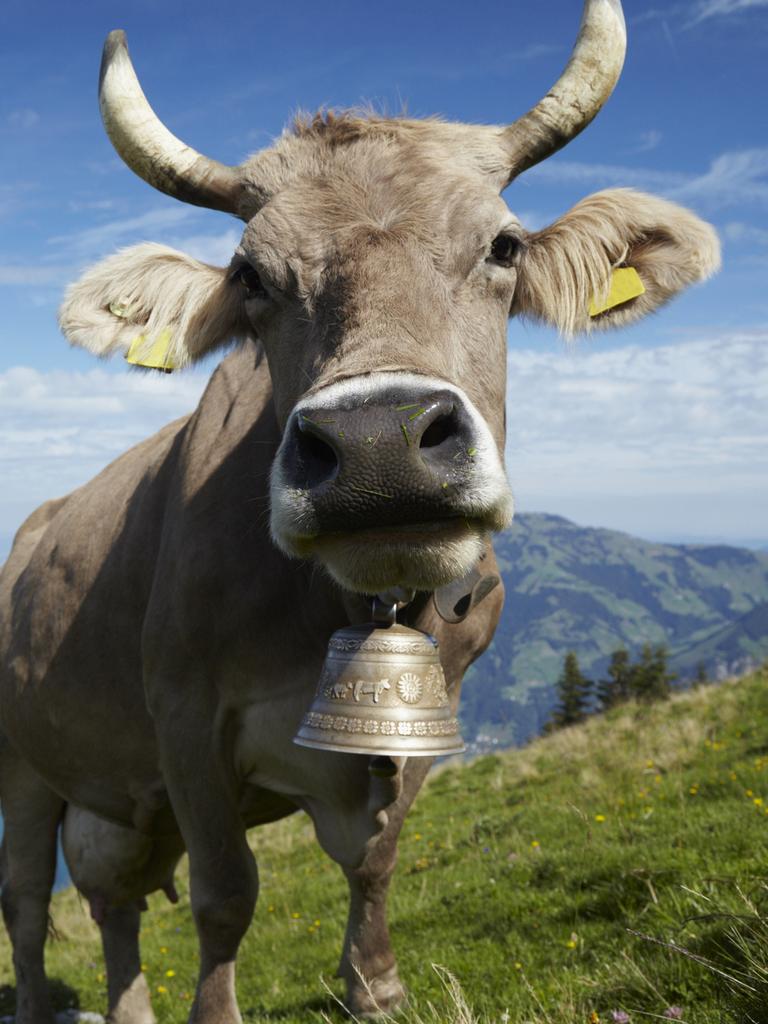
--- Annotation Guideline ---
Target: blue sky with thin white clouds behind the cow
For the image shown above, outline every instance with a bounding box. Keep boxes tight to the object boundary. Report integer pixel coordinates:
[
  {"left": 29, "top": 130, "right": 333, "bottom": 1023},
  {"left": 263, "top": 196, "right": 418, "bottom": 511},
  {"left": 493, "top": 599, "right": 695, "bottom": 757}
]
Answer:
[{"left": 0, "top": 0, "right": 768, "bottom": 557}]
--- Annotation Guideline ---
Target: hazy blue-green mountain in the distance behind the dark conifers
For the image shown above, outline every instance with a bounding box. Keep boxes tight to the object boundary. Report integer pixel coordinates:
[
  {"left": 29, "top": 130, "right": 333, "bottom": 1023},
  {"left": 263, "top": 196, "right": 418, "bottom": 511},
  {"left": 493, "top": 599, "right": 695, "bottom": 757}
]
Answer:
[{"left": 461, "top": 513, "right": 768, "bottom": 753}]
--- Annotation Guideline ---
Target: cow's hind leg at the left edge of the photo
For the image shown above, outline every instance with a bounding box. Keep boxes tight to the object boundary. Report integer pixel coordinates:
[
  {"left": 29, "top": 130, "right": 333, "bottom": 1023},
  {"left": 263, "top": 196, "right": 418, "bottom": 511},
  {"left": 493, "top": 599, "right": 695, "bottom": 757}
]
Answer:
[{"left": 0, "top": 740, "right": 63, "bottom": 1024}]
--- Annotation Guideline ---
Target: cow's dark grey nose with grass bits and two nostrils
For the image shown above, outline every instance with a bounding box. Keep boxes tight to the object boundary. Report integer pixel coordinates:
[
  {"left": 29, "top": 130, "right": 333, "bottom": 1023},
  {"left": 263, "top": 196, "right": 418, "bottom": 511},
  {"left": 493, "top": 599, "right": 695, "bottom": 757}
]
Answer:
[{"left": 282, "top": 388, "right": 477, "bottom": 530}]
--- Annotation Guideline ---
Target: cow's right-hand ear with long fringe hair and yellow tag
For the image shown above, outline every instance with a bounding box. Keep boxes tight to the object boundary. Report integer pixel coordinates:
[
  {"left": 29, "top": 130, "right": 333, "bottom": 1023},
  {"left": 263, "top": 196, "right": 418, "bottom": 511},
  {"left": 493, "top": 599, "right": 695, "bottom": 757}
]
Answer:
[{"left": 512, "top": 188, "right": 720, "bottom": 336}]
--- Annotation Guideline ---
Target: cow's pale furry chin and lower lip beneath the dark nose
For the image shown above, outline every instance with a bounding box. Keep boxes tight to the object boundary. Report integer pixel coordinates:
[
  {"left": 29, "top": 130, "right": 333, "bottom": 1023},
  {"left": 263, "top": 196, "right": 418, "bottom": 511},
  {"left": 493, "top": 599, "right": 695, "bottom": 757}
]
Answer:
[{"left": 311, "top": 518, "right": 487, "bottom": 594}]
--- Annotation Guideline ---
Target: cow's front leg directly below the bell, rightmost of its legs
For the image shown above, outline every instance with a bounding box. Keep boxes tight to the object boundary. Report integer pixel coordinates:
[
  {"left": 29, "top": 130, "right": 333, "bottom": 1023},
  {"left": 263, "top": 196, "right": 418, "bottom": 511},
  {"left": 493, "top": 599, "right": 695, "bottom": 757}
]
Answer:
[{"left": 308, "top": 758, "right": 432, "bottom": 1019}]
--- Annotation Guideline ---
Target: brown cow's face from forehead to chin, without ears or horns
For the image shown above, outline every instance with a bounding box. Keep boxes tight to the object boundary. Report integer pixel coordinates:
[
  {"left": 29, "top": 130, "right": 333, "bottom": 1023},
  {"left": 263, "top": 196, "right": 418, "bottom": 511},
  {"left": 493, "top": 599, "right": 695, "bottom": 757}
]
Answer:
[{"left": 230, "top": 131, "right": 522, "bottom": 592}]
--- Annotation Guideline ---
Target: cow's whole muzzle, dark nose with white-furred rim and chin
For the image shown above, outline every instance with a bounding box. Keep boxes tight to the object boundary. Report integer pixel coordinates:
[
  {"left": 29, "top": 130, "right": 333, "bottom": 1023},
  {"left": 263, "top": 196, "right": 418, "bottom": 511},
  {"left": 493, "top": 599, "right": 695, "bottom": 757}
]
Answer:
[{"left": 271, "top": 374, "right": 512, "bottom": 591}]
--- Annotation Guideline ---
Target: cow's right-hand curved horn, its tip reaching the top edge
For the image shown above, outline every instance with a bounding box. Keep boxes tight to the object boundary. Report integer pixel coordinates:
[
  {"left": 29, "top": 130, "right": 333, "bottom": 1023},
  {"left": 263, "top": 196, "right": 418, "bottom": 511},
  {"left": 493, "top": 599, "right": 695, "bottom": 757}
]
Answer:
[{"left": 502, "top": 0, "right": 627, "bottom": 181}]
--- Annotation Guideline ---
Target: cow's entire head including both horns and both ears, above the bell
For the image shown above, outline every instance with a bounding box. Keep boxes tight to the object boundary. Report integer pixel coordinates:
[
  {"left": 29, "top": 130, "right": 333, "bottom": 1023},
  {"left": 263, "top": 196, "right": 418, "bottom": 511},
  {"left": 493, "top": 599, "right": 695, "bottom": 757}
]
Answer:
[{"left": 60, "top": 0, "right": 718, "bottom": 592}]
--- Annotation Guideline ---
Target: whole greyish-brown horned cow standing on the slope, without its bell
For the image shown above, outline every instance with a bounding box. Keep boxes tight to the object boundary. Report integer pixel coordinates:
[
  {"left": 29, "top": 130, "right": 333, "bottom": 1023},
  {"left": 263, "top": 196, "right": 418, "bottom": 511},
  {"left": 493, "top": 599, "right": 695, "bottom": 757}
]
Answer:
[{"left": 0, "top": 0, "right": 719, "bottom": 1024}]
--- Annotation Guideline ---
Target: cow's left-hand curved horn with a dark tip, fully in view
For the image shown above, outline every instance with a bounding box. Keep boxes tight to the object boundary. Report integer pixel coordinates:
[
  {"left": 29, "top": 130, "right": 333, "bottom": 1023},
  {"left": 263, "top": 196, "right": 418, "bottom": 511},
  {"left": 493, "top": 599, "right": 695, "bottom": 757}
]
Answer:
[{"left": 98, "top": 30, "right": 242, "bottom": 213}]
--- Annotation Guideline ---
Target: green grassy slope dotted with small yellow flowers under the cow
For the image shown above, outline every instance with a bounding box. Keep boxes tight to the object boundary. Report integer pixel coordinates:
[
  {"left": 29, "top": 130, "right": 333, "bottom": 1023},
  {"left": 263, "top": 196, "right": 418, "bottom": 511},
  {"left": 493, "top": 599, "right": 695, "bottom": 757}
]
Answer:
[{"left": 0, "top": 671, "right": 768, "bottom": 1024}]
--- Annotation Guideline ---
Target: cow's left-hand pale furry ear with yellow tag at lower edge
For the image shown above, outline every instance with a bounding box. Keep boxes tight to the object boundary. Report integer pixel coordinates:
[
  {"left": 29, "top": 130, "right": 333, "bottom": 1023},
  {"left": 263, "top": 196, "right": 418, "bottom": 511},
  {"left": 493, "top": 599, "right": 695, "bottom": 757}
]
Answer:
[{"left": 58, "top": 244, "right": 248, "bottom": 369}]
